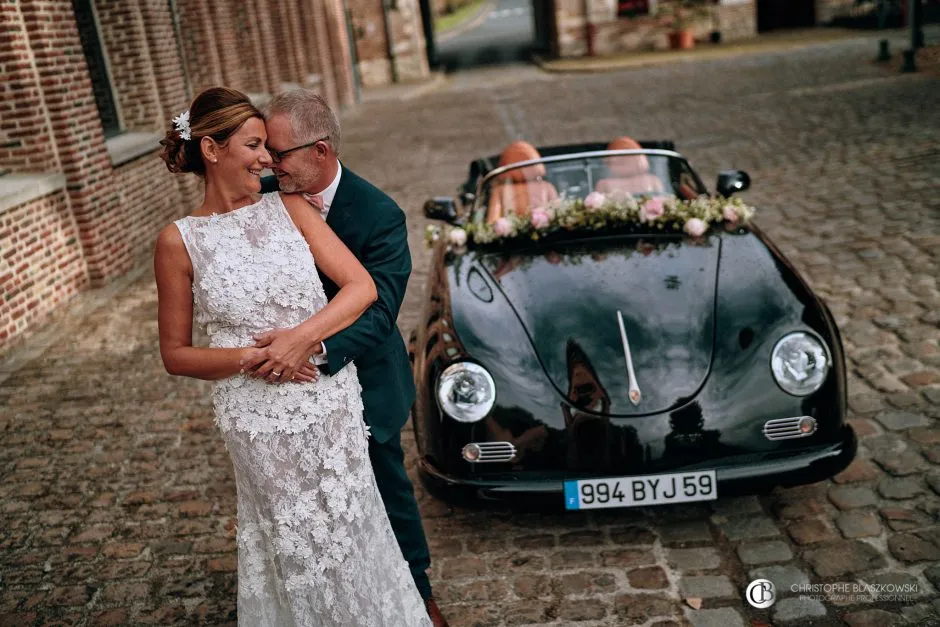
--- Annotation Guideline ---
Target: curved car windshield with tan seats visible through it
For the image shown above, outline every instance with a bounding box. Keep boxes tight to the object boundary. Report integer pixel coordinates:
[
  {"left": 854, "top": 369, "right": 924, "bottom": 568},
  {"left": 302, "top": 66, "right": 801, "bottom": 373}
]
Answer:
[{"left": 472, "top": 150, "right": 706, "bottom": 224}]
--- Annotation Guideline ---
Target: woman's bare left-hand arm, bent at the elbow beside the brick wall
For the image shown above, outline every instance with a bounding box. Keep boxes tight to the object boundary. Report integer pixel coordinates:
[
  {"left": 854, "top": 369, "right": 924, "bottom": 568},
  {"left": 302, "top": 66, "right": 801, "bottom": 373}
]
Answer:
[{"left": 153, "top": 224, "right": 258, "bottom": 380}]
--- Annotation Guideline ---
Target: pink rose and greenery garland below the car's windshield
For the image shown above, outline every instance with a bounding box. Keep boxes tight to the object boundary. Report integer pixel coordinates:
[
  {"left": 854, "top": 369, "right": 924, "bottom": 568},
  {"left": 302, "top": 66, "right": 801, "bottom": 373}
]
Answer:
[{"left": 425, "top": 192, "right": 754, "bottom": 248}]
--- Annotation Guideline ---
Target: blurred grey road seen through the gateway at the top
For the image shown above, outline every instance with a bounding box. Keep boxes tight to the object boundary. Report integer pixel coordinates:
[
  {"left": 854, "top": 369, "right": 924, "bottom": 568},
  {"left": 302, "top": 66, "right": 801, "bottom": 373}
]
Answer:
[{"left": 437, "top": 0, "right": 534, "bottom": 72}]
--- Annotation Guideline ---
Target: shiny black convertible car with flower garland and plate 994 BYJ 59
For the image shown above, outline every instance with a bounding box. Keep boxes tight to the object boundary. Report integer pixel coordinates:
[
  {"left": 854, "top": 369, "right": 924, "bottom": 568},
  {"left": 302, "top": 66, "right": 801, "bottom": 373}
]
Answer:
[{"left": 410, "top": 141, "right": 856, "bottom": 509}]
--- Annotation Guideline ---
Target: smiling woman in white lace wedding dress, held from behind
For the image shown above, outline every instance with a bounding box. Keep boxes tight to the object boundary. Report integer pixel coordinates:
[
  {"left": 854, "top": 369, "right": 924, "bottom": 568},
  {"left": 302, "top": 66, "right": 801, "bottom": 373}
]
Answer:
[{"left": 154, "top": 87, "right": 430, "bottom": 627}]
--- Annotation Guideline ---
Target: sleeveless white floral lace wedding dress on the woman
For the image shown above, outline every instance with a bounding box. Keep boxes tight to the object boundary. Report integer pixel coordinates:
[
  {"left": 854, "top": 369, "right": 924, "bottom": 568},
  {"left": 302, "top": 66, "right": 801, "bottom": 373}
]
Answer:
[{"left": 176, "top": 193, "right": 430, "bottom": 627}]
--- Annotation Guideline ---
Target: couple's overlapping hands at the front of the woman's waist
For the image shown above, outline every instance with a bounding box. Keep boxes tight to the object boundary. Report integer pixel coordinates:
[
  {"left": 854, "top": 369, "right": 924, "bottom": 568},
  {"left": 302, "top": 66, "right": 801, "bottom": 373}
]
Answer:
[{"left": 242, "top": 328, "right": 320, "bottom": 383}]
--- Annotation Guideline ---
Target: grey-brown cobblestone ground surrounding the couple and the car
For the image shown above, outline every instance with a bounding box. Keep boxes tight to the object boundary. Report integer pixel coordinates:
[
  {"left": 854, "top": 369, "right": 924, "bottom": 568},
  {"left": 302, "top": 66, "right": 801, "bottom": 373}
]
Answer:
[{"left": 0, "top": 33, "right": 940, "bottom": 627}]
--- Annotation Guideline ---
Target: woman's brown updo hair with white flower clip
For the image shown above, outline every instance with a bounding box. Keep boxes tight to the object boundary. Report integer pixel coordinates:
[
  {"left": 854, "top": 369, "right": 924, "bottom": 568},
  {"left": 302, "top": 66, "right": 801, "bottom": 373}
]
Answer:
[{"left": 160, "top": 87, "right": 263, "bottom": 176}]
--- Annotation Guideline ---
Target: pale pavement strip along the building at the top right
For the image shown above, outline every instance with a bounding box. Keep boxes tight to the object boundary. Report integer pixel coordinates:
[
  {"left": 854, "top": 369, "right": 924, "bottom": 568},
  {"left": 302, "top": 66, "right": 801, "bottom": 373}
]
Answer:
[{"left": 532, "top": 33, "right": 892, "bottom": 74}]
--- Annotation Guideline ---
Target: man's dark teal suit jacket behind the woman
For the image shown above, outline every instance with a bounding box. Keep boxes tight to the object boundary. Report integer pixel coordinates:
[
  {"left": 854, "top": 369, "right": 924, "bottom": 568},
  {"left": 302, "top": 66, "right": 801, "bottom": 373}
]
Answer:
[{"left": 261, "top": 166, "right": 415, "bottom": 442}]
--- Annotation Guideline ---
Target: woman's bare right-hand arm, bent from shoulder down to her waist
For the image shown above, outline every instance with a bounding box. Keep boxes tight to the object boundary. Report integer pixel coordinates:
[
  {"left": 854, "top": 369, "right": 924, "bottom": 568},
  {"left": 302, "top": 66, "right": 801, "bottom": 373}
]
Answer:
[{"left": 245, "top": 194, "right": 378, "bottom": 381}]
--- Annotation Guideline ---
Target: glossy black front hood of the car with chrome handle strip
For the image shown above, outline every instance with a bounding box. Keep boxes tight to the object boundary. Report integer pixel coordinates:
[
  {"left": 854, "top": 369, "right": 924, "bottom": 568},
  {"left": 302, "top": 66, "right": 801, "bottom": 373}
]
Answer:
[{"left": 480, "top": 235, "right": 721, "bottom": 416}]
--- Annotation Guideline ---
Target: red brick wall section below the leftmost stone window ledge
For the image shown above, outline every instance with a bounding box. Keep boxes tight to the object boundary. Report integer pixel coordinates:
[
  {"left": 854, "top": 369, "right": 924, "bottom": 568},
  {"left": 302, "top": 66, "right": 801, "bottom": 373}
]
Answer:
[{"left": 0, "top": 190, "right": 88, "bottom": 350}]
